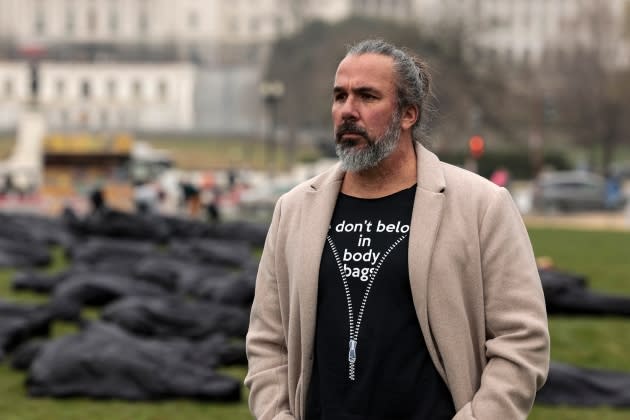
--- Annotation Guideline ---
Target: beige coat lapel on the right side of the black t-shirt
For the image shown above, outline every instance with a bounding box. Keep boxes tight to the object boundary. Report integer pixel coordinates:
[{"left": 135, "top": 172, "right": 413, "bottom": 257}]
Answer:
[{"left": 408, "top": 145, "right": 446, "bottom": 378}]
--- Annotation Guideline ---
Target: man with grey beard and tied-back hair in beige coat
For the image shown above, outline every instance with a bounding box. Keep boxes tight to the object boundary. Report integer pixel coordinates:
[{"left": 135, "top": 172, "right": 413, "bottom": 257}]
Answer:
[{"left": 245, "top": 40, "right": 549, "bottom": 420}]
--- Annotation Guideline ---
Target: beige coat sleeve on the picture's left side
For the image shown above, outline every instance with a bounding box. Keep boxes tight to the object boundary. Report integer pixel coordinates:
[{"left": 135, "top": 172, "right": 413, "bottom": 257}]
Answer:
[{"left": 245, "top": 199, "right": 294, "bottom": 420}]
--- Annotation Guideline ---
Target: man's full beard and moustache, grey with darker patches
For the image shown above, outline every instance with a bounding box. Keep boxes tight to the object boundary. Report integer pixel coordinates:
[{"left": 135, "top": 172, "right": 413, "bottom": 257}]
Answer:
[{"left": 335, "top": 111, "right": 400, "bottom": 172}]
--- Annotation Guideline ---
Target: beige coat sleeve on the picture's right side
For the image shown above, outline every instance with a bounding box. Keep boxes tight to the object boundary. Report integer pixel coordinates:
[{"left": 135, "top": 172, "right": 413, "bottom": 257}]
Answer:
[{"left": 455, "top": 188, "right": 550, "bottom": 420}]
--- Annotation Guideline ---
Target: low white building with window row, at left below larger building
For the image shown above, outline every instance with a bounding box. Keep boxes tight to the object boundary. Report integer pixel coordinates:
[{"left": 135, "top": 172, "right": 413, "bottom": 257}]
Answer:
[{"left": 0, "top": 61, "right": 197, "bottom": 131}]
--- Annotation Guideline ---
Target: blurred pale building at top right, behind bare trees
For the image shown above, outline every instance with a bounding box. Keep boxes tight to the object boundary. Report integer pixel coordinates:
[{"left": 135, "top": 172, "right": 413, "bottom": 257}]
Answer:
[{"left": 415, "top": 0, "right": 630, "bottom": 67}]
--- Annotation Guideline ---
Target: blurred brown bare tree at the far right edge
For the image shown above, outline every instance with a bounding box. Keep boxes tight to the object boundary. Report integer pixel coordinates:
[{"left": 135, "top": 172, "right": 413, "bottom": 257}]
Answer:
[{"left": 548, "top": 2, "right": 630, "bottom": 173}]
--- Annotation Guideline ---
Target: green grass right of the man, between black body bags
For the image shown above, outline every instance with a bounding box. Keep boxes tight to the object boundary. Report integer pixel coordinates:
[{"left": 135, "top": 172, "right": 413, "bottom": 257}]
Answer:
[{"left": 529, "top": 228, "right": 630, "bottom": 420}]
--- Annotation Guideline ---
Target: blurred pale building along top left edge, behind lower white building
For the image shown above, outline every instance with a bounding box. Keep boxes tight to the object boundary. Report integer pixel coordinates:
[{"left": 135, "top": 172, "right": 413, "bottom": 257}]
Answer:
[{"left": 0, "top": 0, "right": 296, "bottom": 44}]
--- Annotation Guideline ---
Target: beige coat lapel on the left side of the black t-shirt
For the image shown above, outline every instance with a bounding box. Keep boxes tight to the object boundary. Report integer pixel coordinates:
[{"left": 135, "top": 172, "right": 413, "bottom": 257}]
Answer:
[{"left": 298, "top": 165, "right": 343, "bottom": 366}]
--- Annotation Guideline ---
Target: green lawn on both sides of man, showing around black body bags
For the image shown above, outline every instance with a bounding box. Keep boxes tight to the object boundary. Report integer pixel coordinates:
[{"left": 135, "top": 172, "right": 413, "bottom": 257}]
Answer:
[{"left": 0, "top": 228, "right": 630, "bottom": 420}]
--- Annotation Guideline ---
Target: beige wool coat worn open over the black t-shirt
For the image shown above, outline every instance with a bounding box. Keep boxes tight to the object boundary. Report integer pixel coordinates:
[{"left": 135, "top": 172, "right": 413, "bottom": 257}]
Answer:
[{"left": 245, "top": 145, "right": 549, "bottom": 420}]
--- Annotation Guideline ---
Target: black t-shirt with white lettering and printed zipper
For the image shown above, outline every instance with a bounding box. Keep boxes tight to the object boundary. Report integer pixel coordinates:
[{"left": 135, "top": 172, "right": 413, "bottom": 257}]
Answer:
[{"left": 306, "top": 186, "right": 455, "bottom": 420}]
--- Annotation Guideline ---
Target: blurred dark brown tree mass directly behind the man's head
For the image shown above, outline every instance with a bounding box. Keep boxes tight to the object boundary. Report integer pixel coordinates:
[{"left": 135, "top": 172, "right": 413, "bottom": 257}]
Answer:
[{"left": 267, "top": 17, "right": 508, "bottom": 157}]
